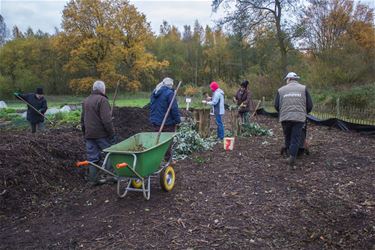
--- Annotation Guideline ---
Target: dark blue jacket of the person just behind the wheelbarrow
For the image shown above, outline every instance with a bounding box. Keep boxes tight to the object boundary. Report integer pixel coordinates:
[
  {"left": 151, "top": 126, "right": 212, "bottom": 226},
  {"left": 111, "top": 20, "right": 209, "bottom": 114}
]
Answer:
[{"left": 150, "top": 86, "right": 181, "bottom": 126}]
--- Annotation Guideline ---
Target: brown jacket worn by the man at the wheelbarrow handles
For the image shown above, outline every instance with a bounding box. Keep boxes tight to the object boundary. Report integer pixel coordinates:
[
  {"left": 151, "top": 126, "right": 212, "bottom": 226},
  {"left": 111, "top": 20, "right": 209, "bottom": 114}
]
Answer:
[{"left": 81, "top": 91, "right": 114, "bottom": 139}]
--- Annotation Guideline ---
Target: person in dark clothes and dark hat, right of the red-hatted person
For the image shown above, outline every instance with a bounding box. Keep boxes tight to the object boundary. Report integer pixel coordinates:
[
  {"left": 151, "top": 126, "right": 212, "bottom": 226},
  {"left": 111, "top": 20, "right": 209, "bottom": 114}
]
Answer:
[{"left": 233, "top": 80, "right": 254, "bottom": 125}]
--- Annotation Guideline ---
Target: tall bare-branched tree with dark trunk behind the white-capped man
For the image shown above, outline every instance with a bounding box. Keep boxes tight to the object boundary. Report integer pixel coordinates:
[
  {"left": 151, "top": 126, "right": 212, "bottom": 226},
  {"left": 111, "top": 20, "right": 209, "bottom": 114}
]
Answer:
[{"left": 212, "top": 0, "right": 299, "bottom": 73}]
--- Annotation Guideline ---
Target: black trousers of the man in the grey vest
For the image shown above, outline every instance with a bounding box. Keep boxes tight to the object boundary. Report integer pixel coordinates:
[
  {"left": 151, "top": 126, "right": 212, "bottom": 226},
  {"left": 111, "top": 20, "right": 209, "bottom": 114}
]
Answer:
[{"left": 281, "top": 121, "right": 305, "bottom": 158}]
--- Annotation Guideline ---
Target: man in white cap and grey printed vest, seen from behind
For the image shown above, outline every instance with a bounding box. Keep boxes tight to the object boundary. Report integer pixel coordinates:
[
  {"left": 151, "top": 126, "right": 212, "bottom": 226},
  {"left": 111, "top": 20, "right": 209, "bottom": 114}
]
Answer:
[{"left": 275, "top": 72, "right": 313, "bottom": 166}]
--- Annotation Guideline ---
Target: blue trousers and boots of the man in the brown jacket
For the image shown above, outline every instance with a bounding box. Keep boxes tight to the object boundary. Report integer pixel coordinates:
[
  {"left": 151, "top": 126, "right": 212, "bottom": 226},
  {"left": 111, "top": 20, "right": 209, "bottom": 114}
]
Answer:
[{"left": 86, "top": 138, "right": 111, "bottom": 182}]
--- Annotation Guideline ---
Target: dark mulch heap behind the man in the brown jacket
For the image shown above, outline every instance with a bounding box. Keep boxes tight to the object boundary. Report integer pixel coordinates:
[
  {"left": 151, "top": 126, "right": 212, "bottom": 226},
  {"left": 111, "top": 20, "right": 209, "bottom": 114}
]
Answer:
[{"left": 0, "top": 108, "right": 152, "bottom": 213}]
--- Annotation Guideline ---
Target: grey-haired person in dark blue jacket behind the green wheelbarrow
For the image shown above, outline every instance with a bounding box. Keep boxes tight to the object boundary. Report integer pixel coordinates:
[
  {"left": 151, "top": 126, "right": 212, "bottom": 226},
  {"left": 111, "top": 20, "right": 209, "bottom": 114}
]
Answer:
[{"left": 150, "top": 77, "right": 181, "bottom": 132}]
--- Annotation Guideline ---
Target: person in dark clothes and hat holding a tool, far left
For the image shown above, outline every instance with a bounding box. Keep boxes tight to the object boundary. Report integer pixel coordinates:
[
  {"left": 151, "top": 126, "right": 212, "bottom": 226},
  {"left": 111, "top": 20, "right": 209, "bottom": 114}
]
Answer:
[{"left": 14, "top": 87, "right": 48, "bottom": 133}]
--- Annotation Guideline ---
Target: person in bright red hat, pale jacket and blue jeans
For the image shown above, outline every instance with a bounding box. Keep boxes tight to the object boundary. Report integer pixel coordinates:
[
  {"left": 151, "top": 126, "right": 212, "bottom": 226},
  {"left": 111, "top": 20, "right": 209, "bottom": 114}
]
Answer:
[{"left": 203, "top": 82, "right": 225, "bottom": 140}]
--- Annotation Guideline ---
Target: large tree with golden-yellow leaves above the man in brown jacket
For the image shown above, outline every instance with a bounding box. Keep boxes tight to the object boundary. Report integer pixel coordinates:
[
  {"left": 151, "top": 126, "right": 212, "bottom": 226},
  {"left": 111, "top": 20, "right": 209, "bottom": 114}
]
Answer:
[{"left": 55, "top": 0, "right": 166, "bottom": 91}]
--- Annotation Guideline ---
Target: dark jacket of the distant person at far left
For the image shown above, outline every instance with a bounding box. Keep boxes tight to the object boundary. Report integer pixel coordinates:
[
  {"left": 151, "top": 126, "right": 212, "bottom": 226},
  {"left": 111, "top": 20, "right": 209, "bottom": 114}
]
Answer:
[{"left": 19, "top": 93, "right": 48, "bottom": 124}]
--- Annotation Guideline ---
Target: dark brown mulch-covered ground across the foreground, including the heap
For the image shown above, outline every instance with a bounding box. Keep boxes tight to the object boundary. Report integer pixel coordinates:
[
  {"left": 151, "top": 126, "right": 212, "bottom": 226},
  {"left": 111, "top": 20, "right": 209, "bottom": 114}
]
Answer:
[{"left": 0, "top": 109, "right": 375, "bottom": 249}]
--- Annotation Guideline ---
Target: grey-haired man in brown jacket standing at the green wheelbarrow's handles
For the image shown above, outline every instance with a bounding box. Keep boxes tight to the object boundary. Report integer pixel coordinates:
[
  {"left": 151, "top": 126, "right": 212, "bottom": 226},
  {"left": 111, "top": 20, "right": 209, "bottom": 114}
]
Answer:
[{"left": 81, "top": 81, "right": 115, "bottom": 185}]
